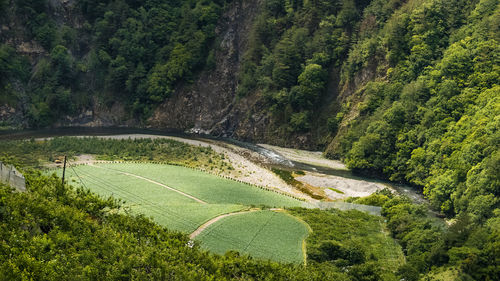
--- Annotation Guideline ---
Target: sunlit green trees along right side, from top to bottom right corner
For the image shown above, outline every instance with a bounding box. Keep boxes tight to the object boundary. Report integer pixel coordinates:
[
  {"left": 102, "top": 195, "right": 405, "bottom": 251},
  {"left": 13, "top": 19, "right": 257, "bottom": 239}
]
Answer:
[{"left": 327, "top": 0, "right": 500, "bottom": 280}]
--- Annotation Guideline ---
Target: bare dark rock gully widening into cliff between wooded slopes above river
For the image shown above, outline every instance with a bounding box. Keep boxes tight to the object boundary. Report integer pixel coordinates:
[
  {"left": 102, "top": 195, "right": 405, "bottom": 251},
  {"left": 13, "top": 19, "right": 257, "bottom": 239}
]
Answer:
[{"left": 148, "top": 0, "right": 326, "bottom": 148}]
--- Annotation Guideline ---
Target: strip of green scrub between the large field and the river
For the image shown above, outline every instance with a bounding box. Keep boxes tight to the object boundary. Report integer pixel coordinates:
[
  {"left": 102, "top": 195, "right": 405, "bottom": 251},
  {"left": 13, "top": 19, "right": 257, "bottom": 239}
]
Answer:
[{"left": 0, "top": 137, "right": 232, "bottom": 172}]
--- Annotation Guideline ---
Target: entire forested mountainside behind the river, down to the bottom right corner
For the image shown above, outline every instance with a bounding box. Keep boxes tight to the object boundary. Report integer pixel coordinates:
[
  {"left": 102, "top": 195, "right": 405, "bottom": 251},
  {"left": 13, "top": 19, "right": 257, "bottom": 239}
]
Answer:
[{"left": 0, "top": 0, "right": 500, "bottom": 280}]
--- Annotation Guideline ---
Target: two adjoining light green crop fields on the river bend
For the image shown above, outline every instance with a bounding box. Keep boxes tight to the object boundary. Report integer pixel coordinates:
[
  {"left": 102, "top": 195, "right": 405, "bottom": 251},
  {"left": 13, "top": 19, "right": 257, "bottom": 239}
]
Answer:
[{"left": 51, "top": 163, "right": 308, "bottom": 263}]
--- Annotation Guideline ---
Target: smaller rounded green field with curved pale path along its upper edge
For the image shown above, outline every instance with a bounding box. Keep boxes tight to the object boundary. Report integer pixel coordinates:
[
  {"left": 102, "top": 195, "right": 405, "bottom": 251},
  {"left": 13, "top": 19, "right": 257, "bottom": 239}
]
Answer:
[{"left": 196, "top": 211, "right": 309, "bottom": 263}]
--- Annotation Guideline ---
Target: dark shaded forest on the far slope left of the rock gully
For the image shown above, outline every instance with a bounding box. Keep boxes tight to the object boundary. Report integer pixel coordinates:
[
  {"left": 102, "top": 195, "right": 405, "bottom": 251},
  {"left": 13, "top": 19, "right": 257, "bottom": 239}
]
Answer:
[{"left": 0, "top": 0, "right": 226, "bottom": 127}]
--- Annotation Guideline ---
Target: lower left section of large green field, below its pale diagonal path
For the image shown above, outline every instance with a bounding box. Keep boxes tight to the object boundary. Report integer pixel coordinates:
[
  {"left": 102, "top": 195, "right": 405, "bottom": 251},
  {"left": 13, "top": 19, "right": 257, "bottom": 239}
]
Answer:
[{"left": 57, "top": 164, "right": 245, "bottom": 233}]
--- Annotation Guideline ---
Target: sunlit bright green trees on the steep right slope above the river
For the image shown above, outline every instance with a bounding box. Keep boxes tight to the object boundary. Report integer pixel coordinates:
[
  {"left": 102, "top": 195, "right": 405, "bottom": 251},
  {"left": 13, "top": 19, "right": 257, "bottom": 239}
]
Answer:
[{"left": 329, "top": 0, "right": 500, "bottom": 217}]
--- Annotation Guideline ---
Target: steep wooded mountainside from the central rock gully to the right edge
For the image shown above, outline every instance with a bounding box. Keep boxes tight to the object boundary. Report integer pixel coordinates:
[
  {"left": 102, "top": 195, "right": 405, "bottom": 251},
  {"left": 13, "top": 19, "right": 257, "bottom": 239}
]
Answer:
[{"left": 152, "top": 0, "right": 500, "bottom": 218}]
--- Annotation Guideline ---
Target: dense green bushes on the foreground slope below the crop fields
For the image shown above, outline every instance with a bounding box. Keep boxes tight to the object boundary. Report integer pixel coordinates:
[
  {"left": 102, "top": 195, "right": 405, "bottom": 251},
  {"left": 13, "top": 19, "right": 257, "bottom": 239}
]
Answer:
[{"left": 0, "top": 171, "right": 356, "bottom": 281}]
